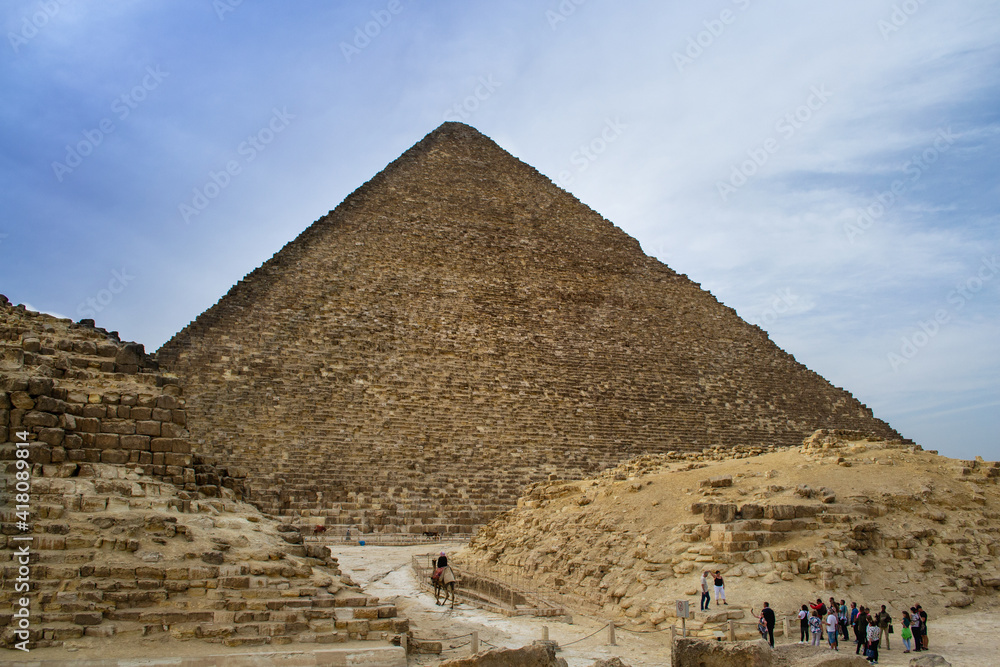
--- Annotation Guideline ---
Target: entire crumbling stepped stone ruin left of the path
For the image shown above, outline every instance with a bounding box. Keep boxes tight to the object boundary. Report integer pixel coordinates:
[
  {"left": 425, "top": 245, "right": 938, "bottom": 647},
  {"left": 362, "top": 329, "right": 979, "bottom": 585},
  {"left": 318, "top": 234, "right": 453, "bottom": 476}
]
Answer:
[{"left": 0, "top": 296, "right": 407, "bottom": 649}]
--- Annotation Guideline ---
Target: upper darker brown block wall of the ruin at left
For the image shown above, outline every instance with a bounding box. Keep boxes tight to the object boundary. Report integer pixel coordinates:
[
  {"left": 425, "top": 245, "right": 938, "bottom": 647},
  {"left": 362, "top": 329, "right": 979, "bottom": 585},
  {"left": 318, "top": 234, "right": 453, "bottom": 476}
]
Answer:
[{"left": 0, "top": 310, "right": 246, "bottom": 498}]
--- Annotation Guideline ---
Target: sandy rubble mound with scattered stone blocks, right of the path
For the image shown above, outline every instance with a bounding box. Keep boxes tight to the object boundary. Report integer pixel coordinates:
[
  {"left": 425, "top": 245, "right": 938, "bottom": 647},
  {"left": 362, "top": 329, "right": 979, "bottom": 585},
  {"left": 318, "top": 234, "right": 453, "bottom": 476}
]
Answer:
[{"left": 456, "top": 431, "right": 1000, "bottom": 635}]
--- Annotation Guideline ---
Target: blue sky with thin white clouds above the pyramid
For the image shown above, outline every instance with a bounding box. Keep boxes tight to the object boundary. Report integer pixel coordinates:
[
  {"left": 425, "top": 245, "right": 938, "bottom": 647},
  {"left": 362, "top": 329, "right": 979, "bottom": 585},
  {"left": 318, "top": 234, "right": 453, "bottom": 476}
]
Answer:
[{"left": 0, "top": 0, "right": 1000, "bottom": 460}]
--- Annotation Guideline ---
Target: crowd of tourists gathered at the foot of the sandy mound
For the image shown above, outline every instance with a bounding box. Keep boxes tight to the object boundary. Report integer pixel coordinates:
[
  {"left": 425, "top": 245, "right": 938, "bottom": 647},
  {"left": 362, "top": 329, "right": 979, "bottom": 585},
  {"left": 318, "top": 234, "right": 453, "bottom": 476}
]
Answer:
[{"left": 784, "top": 598, "right": 927, "bottom": 665}]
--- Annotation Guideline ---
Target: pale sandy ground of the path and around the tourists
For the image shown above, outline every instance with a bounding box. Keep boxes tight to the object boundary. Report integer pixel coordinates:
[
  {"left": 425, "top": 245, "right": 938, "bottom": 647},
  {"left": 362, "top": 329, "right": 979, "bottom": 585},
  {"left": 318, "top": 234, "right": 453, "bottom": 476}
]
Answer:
[{"left": 332, "top": 543, "right": 1000, "bottom": 667}]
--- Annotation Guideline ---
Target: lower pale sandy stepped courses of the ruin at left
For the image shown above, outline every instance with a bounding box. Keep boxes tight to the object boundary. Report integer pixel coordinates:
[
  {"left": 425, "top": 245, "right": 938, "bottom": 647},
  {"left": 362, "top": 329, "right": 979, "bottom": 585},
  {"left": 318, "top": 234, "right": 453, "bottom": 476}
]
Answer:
[{"left": 0, "top": 460, "right": 407, "bottom": 646}]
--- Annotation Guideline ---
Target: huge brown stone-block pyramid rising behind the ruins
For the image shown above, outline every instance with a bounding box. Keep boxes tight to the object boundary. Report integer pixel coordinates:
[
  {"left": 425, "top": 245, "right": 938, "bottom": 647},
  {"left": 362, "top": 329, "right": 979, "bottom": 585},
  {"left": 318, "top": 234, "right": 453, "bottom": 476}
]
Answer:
[{"left": 156, "top": 123, "right": 899, "bottom": 533}]
